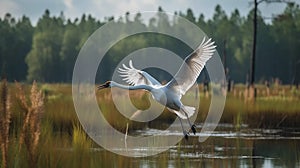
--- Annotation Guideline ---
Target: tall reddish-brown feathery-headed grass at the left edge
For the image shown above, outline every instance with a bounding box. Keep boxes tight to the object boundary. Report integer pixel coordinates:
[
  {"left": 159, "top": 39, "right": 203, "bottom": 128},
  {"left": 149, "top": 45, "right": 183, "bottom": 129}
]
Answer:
[{"left": 0, "top": 80, "right": 44, "bottom": 168}]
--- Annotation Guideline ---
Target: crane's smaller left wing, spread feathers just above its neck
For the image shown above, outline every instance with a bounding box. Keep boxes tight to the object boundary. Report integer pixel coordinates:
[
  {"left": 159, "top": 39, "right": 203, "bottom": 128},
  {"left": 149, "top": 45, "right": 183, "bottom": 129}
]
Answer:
[{"left": 119, "top": 60, "right": 161, "bottom": 86}]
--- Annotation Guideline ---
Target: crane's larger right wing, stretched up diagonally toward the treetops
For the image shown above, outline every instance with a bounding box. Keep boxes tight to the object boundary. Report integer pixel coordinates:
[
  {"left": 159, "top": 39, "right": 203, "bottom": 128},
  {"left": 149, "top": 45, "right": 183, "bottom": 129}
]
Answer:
[{"left": 167, "top": 38, "right": 216, "bottom": 97}]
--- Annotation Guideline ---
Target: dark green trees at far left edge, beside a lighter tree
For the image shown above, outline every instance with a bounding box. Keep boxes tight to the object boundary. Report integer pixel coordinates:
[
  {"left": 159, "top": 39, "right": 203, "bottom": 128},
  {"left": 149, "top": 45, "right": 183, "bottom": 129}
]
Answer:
[{"left": 0, "top": 14, "right": 34, "bottom": 81}]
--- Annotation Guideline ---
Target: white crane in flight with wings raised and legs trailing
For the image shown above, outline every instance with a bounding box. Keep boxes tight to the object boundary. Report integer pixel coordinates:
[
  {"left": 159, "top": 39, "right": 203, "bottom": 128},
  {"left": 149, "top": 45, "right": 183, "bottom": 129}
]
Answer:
[{"left": 98, "top": 38, "right": 216, "bottom": 139}]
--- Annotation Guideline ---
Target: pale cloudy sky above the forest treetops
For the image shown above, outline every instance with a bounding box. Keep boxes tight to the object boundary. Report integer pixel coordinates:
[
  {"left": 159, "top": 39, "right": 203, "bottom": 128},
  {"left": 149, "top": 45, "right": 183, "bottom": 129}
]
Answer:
[{"left": 0, "top": 0, "right": 300, "bottom": 24}]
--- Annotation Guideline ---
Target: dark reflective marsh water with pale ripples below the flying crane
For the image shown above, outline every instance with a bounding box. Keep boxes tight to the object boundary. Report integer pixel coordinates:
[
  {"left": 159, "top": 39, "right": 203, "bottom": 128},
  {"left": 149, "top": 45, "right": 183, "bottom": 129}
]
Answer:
[{"left": 85, "top": 124, "right": 300, "bottom": 168}]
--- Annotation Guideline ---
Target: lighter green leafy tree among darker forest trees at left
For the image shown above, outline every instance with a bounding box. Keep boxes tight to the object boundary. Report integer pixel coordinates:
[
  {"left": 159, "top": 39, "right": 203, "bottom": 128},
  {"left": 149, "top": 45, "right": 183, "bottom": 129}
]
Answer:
[{"left": 26, "top": 11, "right": 64, "bottom": 82}]
